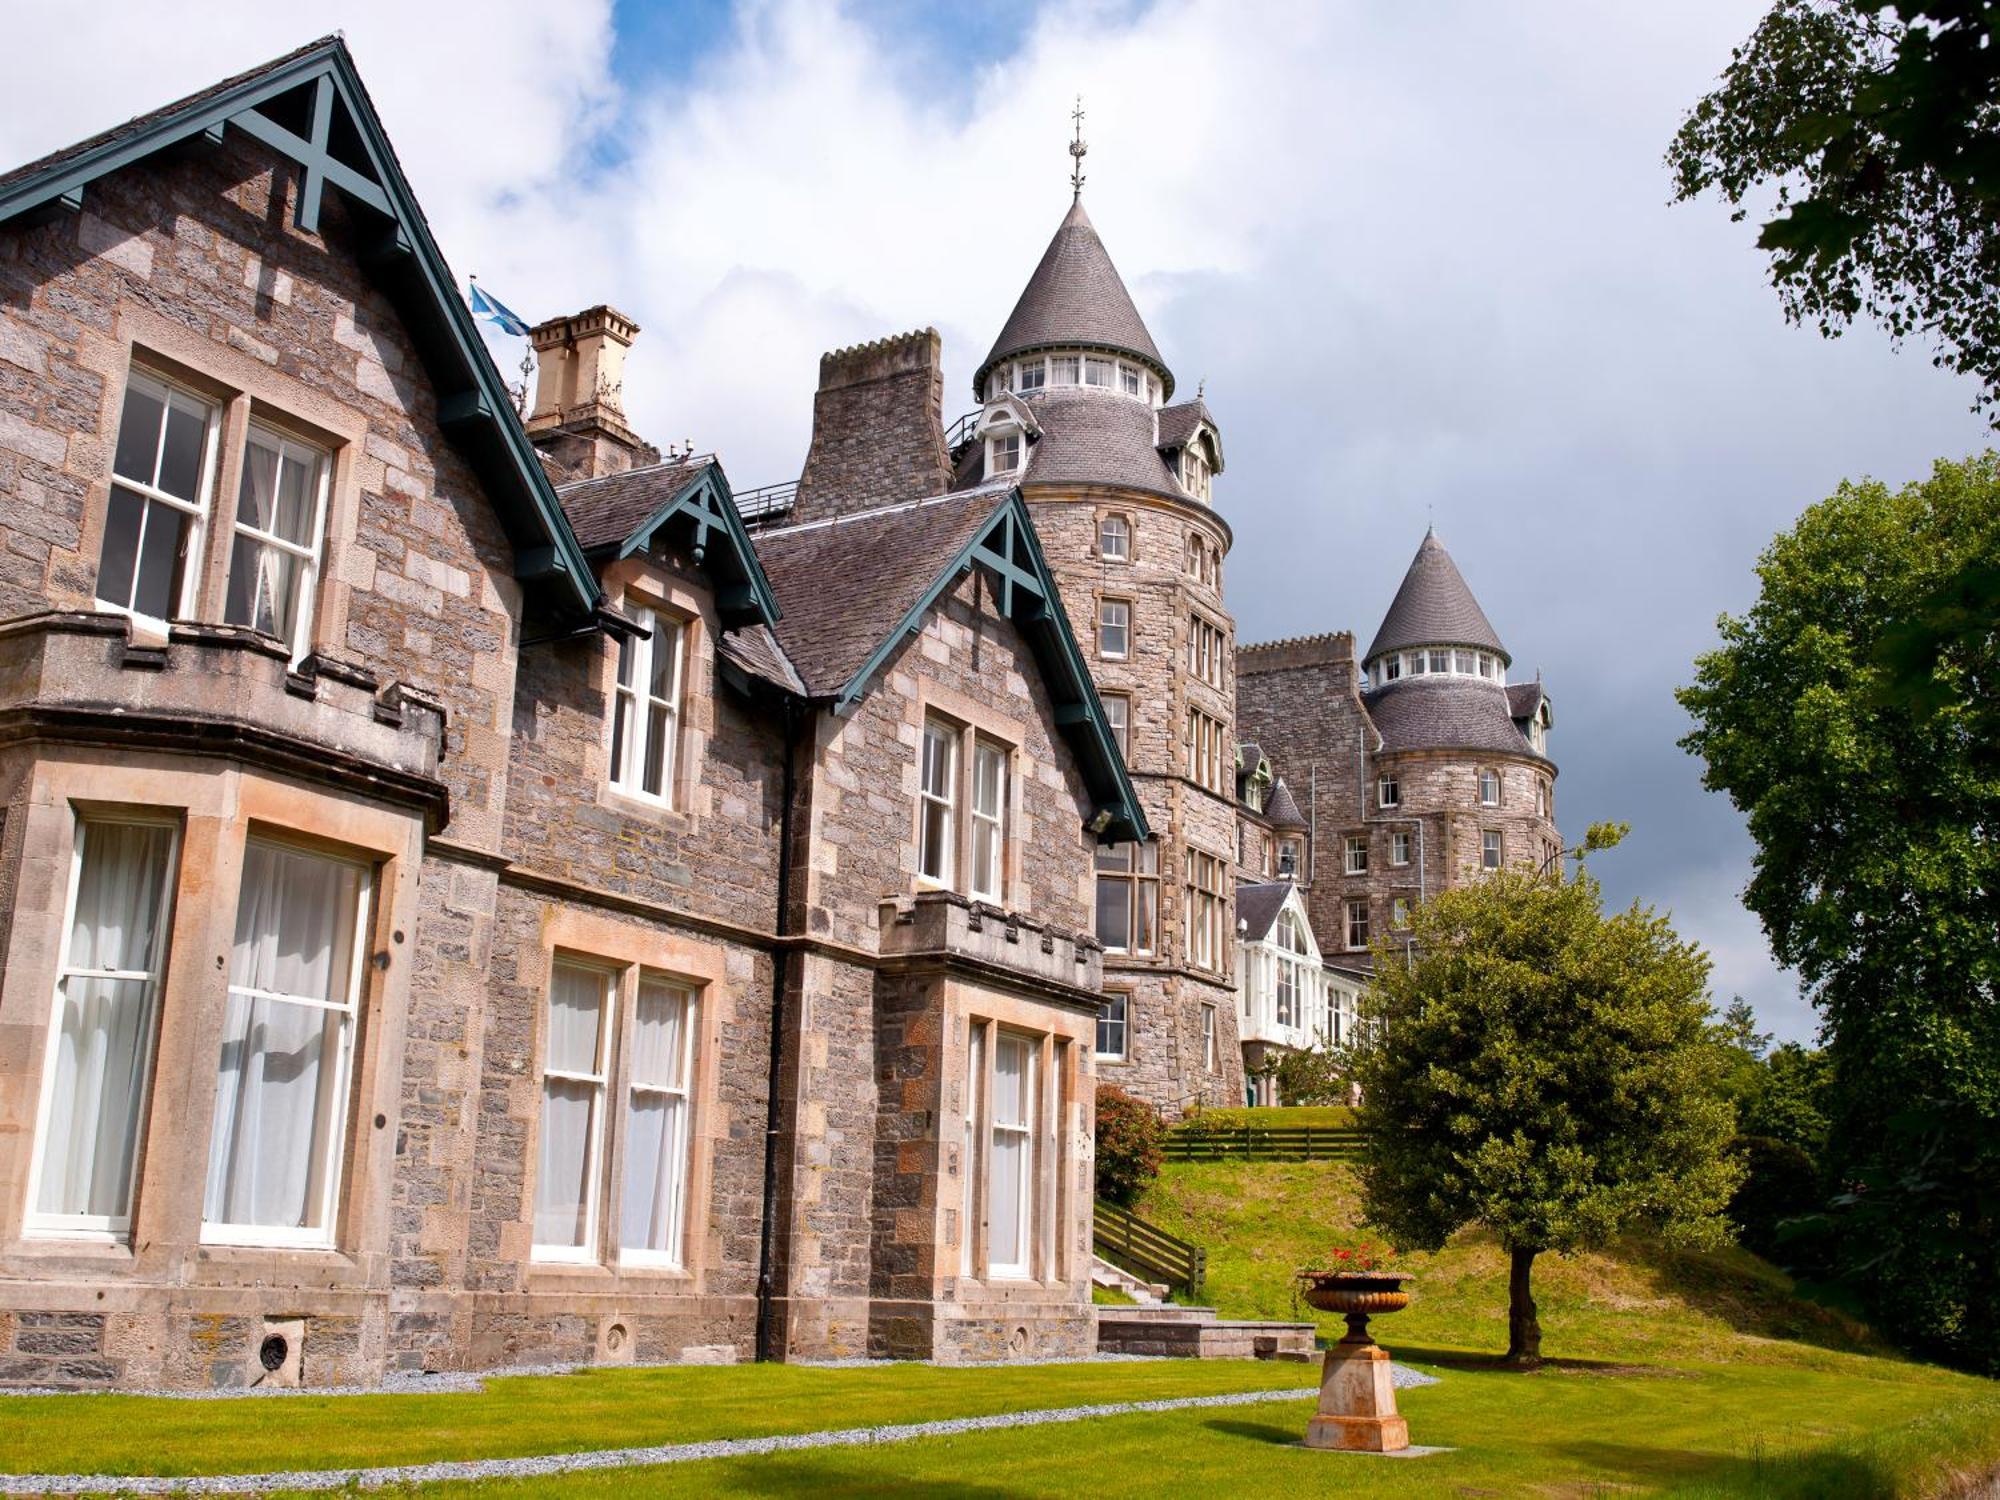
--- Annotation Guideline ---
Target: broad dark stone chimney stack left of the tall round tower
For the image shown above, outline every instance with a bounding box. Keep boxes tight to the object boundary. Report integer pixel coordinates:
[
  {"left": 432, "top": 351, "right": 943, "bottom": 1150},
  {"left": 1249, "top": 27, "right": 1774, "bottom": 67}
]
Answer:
[{"left": 792, "top": 328, "right": 952, "bottom": 522}]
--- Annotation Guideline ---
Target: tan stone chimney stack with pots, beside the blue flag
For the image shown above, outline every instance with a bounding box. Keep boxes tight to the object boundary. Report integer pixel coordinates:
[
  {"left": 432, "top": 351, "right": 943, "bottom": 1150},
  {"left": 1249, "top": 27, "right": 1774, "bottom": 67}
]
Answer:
[{"left": 528, "top": 302, "right": 660, "bottom": 484}]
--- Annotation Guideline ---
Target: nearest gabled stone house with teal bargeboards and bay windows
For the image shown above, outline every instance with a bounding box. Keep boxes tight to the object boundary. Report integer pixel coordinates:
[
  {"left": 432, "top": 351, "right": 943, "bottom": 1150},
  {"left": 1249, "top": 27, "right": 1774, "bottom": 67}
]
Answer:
[{"left": 0, "top": 40, "right": 1136, "bottom": 1388}]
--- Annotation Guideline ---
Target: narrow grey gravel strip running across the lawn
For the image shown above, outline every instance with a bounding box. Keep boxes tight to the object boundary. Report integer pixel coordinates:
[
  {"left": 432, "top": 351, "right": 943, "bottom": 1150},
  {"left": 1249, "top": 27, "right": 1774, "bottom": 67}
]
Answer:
[{"left": 0, "top": 1370, "right": 1344, "bottom": 1494}]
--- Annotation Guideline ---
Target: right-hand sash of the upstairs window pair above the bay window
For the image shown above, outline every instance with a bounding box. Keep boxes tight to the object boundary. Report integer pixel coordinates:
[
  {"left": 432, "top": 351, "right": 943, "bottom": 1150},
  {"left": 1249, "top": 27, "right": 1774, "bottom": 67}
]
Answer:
[{"left": 222, "top": 426, "right": 328, "bottom": 660}]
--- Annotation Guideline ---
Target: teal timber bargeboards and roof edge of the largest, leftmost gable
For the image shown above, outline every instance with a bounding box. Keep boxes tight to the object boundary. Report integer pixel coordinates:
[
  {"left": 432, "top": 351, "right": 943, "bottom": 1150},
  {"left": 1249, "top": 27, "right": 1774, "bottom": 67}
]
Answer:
[{"left": 0, "top": 36, "right": 598, "bottom": 614}]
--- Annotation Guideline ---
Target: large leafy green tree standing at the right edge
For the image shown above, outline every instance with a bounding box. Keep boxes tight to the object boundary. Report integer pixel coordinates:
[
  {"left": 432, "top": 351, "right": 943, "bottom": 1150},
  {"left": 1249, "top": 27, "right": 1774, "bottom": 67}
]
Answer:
[{"left": 1680, "top": 454, "right": 2000, "bottom": 1372}]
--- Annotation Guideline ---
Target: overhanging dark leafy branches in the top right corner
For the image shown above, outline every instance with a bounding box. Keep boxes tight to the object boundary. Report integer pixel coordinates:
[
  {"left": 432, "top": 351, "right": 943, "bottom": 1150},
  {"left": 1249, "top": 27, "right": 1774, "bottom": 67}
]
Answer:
[{"left": 1668, "top": 0, "right": 2000, "bottom": 408}]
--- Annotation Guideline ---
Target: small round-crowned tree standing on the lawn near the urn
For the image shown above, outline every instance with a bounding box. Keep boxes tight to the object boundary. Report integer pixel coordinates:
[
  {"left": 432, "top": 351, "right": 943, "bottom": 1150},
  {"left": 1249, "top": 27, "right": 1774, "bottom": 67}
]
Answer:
[{"left": 1350, "top": 870, "right": 1738, "bottom": 1366}]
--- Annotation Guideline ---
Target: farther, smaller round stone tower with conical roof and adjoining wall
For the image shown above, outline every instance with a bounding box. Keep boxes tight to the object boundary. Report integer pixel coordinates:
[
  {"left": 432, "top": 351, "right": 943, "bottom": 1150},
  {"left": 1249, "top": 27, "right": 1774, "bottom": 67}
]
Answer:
[{"left": 1236, "top": 532, "right": 1562, "bottom": 1000}]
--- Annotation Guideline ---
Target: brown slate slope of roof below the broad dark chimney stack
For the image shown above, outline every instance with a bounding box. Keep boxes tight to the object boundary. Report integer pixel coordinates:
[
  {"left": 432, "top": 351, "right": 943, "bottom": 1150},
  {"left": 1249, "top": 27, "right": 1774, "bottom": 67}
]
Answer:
[{"left": 756, "top": 480, "right": 1014, "bottom": 698}]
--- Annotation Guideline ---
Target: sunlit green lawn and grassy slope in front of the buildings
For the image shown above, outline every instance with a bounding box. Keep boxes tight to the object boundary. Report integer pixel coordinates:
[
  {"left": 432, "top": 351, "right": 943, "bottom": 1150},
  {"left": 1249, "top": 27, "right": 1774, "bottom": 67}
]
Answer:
[{"left": 0, "top": 1162, "right": 2000, "bottom": 1500}]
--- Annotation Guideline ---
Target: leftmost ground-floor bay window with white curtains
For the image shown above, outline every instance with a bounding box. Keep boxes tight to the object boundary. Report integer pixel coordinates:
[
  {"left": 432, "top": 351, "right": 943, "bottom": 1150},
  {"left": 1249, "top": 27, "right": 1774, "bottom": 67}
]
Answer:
[{"left": 26, "top": 818, "right": 178, "bottom": 1238}]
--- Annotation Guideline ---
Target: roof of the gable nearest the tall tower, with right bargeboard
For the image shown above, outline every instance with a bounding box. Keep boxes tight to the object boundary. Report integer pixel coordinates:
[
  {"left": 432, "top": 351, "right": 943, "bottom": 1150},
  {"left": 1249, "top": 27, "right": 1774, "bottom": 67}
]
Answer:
[{"left": 756, "top": 482, "right": 1148, "bottom": 840}]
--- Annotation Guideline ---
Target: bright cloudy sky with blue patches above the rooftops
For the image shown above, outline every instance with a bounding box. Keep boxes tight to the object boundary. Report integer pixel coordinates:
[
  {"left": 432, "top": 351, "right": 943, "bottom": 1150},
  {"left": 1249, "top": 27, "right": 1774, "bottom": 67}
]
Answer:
[{"left": 11, "top": 0, "right": 1988, "bottom": 1036}]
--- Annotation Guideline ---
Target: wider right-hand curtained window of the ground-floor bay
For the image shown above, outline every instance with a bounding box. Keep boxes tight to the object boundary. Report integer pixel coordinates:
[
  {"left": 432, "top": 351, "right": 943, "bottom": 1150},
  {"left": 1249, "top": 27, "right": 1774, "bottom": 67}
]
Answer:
[{"left": 202, "top": 838, "right": 370, "bottom": 1244}]
